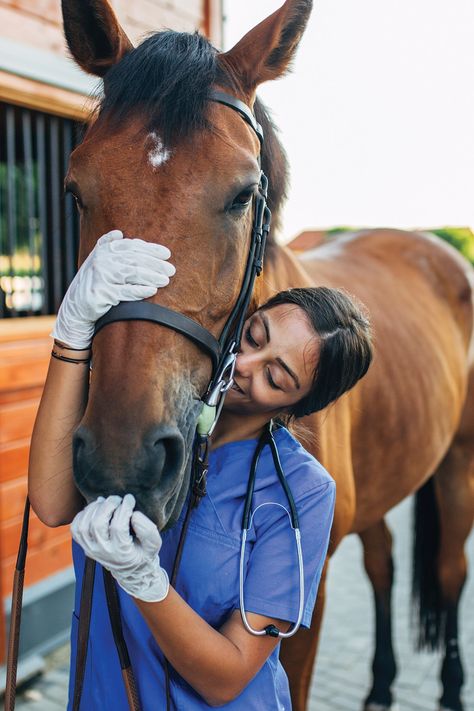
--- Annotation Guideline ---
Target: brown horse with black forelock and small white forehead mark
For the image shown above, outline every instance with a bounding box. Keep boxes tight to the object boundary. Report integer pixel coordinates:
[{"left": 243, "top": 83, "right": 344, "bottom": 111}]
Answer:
[{"left": 63, "top": 0, "right": 474, "bottom": 711}]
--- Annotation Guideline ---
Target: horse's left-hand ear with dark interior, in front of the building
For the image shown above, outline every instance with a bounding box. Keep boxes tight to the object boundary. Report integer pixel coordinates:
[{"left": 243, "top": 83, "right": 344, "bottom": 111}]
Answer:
[{"left": 61, "top": 0, "right": 133, "bottom": 77}]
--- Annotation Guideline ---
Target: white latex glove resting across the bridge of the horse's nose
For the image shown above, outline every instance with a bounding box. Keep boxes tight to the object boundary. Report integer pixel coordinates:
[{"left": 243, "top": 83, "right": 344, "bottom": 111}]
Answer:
[{"left": 51, "top": 230, "right": 176, "bottom": 348}]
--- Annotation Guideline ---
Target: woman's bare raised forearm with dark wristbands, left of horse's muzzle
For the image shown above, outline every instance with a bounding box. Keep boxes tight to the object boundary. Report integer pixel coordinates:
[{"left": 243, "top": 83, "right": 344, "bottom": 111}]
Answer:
[{"left": 28, "top": 347, "right": 90, "bottom": 526}]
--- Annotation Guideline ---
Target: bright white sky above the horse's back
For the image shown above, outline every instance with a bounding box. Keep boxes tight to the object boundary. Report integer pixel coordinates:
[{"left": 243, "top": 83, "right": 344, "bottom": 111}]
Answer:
[{"left": 224, "top": 0, "right": 474, "bottom": 240}]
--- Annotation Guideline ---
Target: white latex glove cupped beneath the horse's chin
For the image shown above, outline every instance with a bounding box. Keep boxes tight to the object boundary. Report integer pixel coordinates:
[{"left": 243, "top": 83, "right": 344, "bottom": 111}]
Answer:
[{"left": 71, "top": 494, "right": 169, "bottom": 602}]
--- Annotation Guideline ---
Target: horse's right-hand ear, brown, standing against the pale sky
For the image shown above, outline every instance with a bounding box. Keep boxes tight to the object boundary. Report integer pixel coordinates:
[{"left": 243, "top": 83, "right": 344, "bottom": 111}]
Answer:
[{"left": 219, "top": 0, "right": 313, "bottom": 94}]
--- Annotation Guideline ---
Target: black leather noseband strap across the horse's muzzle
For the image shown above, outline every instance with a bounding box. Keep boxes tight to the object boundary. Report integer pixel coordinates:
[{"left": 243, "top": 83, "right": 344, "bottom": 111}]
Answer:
[{"left": 94, "top": 301, "right": 221, "bottom": 371}]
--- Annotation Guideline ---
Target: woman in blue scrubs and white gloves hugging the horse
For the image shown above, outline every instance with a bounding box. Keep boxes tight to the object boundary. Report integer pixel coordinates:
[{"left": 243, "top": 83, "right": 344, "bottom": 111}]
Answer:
[{"left": 29, "top": 231, "right": 372, "bottom": 711}]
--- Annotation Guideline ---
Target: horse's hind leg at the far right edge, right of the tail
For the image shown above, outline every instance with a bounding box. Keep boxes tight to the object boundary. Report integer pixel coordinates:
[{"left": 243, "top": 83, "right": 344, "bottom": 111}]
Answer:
[{"left": 434, "top": 436, "right": 474, "bottom": 711}]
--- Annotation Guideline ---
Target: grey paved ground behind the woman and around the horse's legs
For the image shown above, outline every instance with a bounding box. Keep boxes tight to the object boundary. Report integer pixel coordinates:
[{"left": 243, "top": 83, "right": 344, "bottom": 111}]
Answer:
[{"left": 11, "top": 501, "right": 474, "bottom": 711}]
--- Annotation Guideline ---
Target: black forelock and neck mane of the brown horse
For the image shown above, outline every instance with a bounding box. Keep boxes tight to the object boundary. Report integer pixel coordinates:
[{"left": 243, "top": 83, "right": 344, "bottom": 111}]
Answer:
[{"left": 97, "top": 30, "right": 288, "bottom": 247}]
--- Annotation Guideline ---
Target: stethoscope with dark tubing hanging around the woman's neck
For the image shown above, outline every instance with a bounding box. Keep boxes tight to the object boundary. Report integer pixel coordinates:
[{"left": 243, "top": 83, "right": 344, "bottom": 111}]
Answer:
[{"left": 239, "top": 421, "right": 304, "bottom": 638}]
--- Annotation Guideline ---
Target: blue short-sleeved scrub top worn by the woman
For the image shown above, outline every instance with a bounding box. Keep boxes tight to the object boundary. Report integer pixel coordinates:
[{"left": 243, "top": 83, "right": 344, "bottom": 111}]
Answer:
[{"left": 68, "top": 428, "right": 335, "bottom": 711}]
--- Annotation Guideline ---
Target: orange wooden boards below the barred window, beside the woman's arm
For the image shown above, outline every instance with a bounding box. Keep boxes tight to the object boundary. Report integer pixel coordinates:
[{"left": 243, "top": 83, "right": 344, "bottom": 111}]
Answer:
[{"left": 0, "top": 317, "right": 71, "bottom": 662}]
